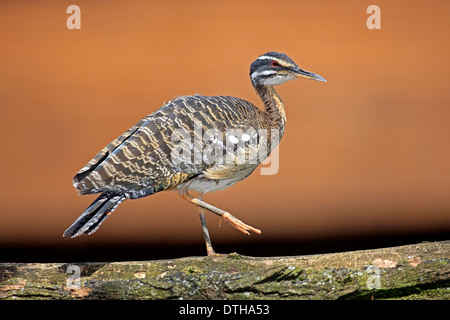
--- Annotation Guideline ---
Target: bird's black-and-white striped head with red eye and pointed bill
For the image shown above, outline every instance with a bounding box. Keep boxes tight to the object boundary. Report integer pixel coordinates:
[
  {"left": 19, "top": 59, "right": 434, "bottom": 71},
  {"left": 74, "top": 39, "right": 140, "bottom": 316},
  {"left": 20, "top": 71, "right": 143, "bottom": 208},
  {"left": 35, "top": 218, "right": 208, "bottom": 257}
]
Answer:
[{"left": 250, "top": 52, "right": 326, "bottom": 87}]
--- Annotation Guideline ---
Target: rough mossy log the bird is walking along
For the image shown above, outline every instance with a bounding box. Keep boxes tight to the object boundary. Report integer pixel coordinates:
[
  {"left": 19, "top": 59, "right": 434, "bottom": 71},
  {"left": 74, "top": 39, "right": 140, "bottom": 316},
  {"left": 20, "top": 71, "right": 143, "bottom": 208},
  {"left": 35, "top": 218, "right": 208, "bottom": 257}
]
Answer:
[{"left": 0, "top": 241, "right": 450, "bottom": 300}]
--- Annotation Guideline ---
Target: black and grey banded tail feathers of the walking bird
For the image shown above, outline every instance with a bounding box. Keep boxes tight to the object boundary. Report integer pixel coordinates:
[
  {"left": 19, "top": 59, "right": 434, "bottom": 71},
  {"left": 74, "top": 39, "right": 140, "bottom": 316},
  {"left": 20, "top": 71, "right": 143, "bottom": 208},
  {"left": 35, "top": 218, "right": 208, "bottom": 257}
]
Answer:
[{"left": 63, "top": 192, "right": 126, "bottom": 238}]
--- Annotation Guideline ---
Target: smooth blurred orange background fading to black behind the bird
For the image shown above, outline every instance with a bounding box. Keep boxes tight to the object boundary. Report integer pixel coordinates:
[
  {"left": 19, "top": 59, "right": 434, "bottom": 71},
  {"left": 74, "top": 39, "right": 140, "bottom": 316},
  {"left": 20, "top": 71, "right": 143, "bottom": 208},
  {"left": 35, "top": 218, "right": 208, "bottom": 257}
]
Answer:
[{"left": 0, "top": 0, "right": 450, "bottom": 260}]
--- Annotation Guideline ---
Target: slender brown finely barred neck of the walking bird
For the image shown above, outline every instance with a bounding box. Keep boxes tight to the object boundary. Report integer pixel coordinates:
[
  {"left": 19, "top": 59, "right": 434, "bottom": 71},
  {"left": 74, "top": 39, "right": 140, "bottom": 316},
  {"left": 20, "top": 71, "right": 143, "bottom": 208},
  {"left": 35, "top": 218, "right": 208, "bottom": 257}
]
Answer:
[{"left": 255, "top": 85, "right": 286, "bottom": 133}]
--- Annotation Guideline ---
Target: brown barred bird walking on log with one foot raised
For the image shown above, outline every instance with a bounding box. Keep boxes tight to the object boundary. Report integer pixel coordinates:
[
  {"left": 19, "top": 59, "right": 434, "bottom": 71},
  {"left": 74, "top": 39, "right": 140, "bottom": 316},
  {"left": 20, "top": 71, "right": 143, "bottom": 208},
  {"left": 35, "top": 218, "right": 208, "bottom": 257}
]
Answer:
[{"left": 63, "top": 51, "right": 326, "bottom": 256}]
